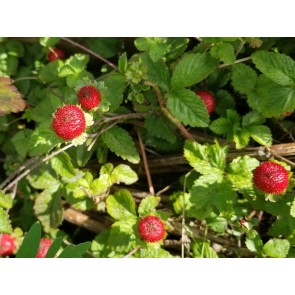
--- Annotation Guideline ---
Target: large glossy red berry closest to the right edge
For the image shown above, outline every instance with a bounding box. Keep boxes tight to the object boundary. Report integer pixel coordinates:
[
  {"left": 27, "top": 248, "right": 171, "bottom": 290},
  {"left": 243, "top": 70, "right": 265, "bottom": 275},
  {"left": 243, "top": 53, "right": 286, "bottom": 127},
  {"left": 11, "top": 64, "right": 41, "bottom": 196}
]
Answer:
[{"left": 253, "top": 161, "right": 289, "bottom": 194}]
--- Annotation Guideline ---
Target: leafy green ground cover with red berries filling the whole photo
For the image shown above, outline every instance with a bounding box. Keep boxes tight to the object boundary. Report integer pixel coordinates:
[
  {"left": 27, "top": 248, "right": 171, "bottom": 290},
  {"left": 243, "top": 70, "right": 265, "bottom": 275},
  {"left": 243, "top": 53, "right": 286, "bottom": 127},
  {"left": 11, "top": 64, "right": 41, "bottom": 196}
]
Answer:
[{"left": 0, "top": 37, "right": 295, "bottom": 258}]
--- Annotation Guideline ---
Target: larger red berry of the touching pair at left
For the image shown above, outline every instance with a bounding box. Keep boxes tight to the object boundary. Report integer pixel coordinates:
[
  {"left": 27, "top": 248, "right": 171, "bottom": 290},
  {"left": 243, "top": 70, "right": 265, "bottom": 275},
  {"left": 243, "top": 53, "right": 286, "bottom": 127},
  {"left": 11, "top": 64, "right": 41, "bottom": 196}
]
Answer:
[{"left": 52, "top": 104, "right": 86, "bottom": 140}]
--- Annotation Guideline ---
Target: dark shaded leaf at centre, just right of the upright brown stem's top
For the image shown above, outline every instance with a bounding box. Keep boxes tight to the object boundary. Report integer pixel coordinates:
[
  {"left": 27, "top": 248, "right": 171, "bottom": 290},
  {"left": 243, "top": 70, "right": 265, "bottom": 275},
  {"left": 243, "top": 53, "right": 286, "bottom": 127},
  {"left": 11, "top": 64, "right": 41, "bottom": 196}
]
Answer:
[{"left": 144, "top": 115, "right": 177, "bottom": 144}]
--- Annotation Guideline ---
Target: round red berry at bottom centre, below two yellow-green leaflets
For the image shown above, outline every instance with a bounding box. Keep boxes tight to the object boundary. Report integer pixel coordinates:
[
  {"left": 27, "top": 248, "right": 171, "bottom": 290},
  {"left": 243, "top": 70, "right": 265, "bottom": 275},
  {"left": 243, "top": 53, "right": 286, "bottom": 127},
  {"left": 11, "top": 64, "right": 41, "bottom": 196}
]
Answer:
[{"left": 138, "top": 215, "right": 166, "bottom": 243}]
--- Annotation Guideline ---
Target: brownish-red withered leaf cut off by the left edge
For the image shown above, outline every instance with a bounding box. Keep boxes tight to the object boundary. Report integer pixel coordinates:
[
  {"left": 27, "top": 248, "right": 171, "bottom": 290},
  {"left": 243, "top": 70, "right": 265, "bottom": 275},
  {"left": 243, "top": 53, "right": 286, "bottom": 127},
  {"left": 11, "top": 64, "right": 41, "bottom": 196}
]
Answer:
[{"left": 0, "top": 77, "right": 26, "bottom": 116}]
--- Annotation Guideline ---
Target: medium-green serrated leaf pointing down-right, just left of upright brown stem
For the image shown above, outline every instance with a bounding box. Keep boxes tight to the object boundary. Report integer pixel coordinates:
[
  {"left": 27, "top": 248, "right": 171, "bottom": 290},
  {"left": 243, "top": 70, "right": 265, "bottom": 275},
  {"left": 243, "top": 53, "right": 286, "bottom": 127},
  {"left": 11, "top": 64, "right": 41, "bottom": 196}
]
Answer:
[{"left": 102, "top": 126, "right": 140, "bottom": 164}]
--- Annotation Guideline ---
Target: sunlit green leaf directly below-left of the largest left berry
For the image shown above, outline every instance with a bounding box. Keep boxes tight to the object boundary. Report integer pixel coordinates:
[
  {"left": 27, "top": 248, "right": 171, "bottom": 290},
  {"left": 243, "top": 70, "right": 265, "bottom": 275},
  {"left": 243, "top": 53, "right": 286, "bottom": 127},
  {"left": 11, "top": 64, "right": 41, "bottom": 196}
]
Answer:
[{"left": 28, "top": 121, "right": 61, "bottom": 156}]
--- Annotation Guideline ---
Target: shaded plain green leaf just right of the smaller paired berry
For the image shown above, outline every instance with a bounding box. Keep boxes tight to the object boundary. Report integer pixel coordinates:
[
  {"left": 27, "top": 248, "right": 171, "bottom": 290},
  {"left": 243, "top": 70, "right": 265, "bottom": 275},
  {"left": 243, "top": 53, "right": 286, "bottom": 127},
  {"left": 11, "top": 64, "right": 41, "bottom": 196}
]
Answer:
[{"left": 104, "top": 73, "right": 126, "bottom": 111}]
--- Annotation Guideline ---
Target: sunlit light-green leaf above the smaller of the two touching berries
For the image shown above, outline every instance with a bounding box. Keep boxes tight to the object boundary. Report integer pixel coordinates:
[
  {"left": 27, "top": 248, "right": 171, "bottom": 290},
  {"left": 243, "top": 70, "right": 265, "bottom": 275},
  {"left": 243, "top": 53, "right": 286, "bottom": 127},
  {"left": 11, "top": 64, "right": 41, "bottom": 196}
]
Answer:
[{"left": 58, "top": 53, "right": 89, "bottom": 77}]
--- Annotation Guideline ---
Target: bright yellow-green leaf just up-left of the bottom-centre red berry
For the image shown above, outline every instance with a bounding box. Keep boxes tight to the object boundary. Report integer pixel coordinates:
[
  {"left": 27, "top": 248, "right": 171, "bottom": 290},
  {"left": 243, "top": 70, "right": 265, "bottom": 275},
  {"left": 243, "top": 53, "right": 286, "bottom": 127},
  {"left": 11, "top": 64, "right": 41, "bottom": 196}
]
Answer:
[{"left": 106, "top": 189, "right": 136, "bottom": 220}]
